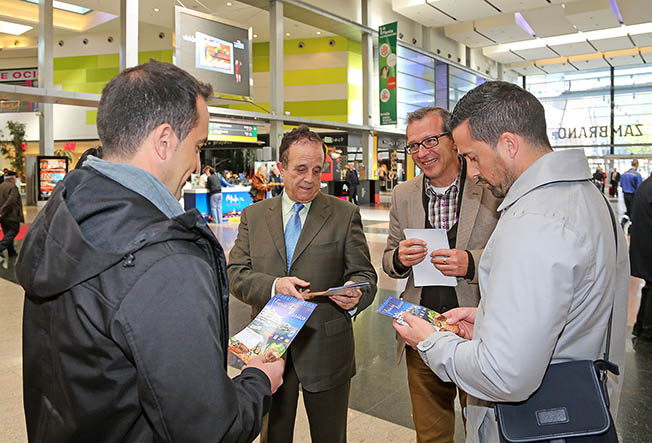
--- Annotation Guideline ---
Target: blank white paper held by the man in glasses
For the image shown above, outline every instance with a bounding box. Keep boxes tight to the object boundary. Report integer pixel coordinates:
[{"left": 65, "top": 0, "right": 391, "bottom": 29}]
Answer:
[{"left": 403, "top": 229, "right": 457, "bottom": 287}]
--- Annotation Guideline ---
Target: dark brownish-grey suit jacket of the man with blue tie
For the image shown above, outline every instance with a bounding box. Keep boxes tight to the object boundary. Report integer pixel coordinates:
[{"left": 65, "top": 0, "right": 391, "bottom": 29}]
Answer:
[{"left": 227, "top": 192, "right": 377, "bottom": 392}]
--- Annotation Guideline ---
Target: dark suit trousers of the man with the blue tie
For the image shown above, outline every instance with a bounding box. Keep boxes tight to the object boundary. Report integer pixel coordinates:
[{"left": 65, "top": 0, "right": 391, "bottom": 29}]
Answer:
[{"left": 260, "top": 352, "right": 351, "bottom": 443}]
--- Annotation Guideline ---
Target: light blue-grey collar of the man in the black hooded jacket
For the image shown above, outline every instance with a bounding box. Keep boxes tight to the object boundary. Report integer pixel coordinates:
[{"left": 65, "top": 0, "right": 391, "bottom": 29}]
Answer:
[{"left": 84, "top": 155, "right": 184, "bottom": 218}]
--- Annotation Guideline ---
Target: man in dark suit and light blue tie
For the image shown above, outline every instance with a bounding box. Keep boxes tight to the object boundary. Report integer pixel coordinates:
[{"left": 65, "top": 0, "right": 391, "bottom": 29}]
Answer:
[{"left": 227, "top": 126, "right": 377, "bottom": 443}]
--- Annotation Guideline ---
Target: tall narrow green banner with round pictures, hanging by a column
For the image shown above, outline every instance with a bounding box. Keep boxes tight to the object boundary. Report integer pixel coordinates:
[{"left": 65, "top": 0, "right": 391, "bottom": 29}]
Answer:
[{"left": 378, "top": 22, "right": 398, "bottom": 125}]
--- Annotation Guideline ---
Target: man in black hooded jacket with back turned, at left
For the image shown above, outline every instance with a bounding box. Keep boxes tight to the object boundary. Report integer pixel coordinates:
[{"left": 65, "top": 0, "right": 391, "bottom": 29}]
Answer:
[{"left": 16, "top": 61, "right": 283, "bottom": 442}]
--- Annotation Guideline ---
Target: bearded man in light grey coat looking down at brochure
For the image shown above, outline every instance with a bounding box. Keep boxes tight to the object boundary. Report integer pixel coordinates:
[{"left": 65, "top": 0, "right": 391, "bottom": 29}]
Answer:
[{"left": 394, "top": 82, "right": 629, "bottom": 442}]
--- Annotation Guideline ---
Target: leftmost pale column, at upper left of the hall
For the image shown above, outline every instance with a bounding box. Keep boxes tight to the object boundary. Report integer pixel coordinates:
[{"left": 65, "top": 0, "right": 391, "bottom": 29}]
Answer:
[{"left": 38, "top": 0, "right": 54, "bottom": 155}]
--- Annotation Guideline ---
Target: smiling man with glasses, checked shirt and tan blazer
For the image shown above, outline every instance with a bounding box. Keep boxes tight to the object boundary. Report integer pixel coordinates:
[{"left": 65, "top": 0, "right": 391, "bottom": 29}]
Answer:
[{"left": 383, "top": 107, "right": 500, "bottom": 442}]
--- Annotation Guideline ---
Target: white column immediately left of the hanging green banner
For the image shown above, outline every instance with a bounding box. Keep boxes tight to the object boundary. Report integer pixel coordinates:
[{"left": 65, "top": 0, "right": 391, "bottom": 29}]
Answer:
[{"left": 360, "top": 0, "right": 376, "bottom": 180}]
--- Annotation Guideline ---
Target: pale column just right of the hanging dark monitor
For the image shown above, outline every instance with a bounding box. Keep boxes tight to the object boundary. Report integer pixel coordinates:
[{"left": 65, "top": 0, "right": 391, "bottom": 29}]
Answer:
[{"left": 269, "top": 0, "right": 285, "bottom": 160}]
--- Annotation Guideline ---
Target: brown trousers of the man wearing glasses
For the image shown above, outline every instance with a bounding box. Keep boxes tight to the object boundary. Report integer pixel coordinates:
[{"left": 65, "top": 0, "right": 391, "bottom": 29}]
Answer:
[{"left": 405, "top": 346, "right": 466, "bottom": 443}]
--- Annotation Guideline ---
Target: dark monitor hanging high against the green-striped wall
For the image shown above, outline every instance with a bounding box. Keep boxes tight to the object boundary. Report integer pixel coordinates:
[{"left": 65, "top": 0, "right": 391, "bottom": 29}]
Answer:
[{"left": 174, "top": 6, "right": 252, "bottom": 101}]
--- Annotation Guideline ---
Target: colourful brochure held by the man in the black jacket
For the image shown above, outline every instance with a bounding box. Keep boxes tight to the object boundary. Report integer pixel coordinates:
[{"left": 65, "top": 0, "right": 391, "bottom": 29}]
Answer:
[{"left": 229, "top": 294, "right": 317, "bottom": 368}]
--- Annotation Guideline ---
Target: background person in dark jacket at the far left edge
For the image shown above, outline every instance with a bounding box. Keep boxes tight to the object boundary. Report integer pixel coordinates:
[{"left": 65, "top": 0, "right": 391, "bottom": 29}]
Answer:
[{"left": 0, "top": 171, "right": 25, "bottom": 269}]
